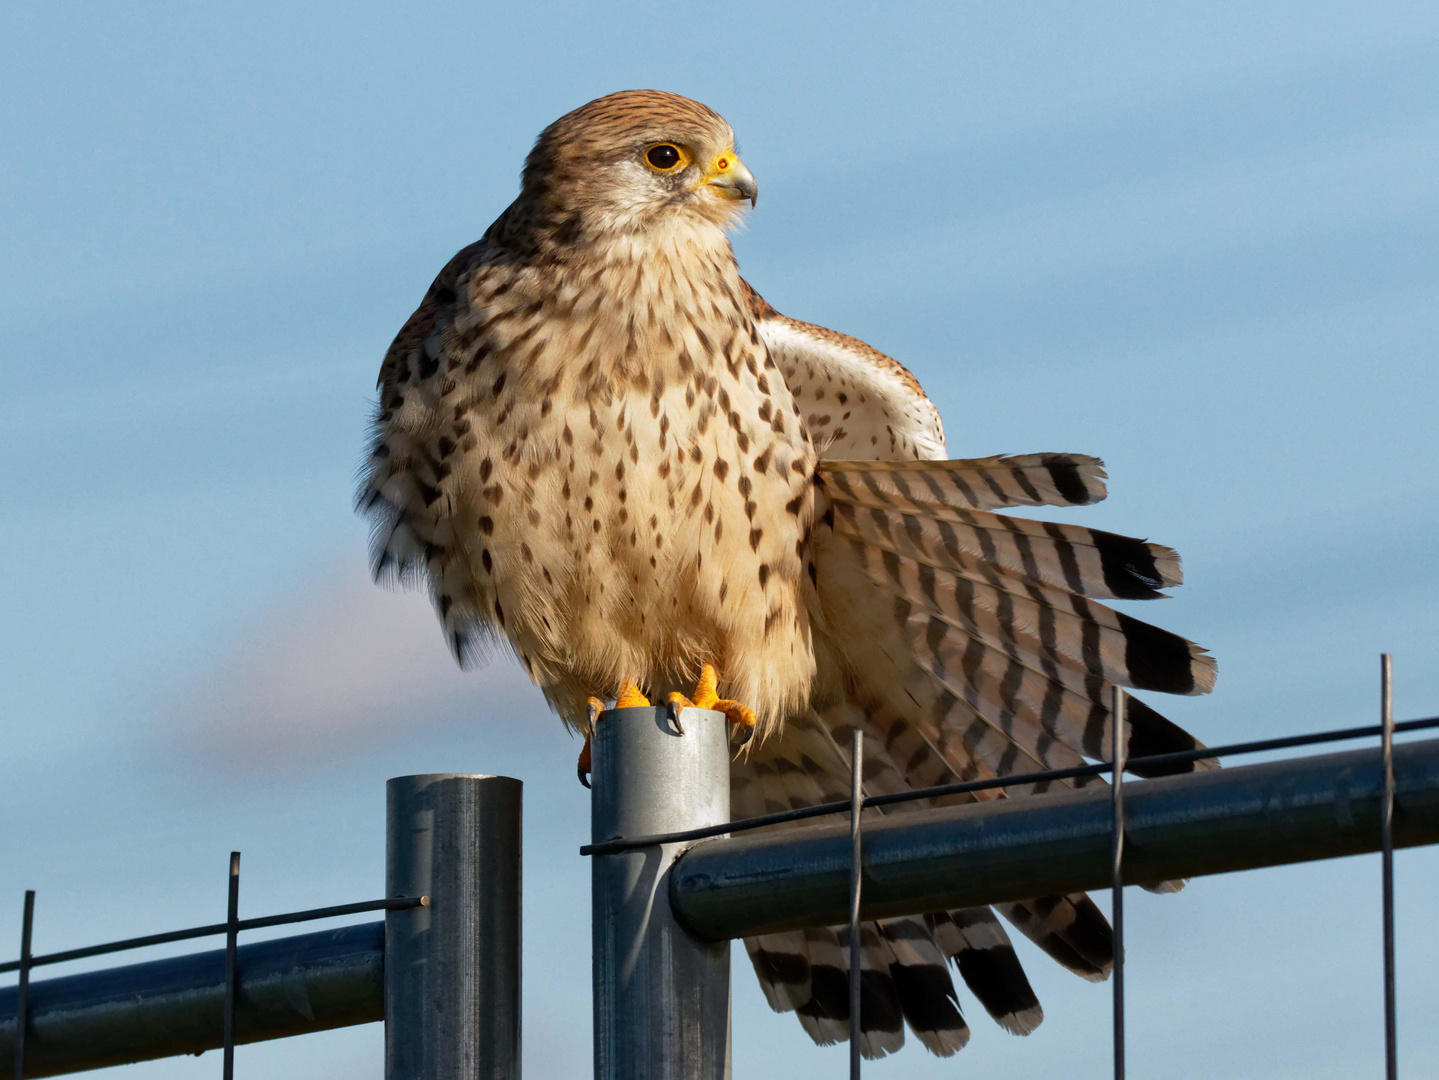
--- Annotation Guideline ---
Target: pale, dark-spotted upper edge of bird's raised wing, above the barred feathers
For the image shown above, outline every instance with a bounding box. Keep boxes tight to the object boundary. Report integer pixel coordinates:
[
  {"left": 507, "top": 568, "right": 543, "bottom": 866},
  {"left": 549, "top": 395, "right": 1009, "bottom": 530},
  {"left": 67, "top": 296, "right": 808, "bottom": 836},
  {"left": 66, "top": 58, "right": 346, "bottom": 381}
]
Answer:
[{"left": 741, "top": 282, "right": 945, "bottom": 460}]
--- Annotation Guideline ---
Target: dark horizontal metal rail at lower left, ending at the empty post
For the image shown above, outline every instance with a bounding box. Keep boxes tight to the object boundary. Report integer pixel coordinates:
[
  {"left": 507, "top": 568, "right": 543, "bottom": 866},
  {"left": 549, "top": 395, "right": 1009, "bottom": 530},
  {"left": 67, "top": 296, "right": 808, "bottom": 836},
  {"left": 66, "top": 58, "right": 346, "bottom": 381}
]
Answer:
[{"left": 0, "top": 920, "right": 385, "bottom": 1080}]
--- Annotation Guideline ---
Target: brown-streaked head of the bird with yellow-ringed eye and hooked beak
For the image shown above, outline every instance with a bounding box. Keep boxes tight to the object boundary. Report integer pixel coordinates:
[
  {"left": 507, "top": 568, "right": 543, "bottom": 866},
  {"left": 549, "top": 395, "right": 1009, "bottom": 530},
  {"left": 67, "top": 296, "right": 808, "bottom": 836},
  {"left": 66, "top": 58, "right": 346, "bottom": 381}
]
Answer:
[{"left": 521, "top": 91, "right": 755, "bottom": 240}]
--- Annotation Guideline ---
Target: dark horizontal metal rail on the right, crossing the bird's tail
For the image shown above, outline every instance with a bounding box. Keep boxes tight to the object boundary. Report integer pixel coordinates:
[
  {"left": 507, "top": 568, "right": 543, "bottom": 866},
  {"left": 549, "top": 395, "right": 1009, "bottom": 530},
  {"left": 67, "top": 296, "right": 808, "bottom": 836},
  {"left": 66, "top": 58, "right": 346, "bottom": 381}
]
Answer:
[{"left": 671, "top": 739, "right": 1439, "bottom": 941}]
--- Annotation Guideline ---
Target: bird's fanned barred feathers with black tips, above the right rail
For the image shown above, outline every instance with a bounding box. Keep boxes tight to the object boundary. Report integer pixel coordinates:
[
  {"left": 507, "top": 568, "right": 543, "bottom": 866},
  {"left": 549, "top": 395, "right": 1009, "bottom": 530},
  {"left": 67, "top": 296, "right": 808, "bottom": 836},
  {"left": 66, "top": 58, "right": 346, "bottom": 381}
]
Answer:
[{"left": 814, "top": 456, "right": 1216, "bottom": 778}]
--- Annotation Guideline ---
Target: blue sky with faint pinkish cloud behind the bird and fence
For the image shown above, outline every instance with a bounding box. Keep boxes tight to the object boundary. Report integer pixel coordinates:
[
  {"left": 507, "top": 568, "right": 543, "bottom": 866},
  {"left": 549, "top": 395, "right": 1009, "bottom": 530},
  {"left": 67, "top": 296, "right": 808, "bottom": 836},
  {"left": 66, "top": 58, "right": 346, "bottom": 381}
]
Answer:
[{"left": 0, "top": 1, "right": 1439, "bottom": 1080}]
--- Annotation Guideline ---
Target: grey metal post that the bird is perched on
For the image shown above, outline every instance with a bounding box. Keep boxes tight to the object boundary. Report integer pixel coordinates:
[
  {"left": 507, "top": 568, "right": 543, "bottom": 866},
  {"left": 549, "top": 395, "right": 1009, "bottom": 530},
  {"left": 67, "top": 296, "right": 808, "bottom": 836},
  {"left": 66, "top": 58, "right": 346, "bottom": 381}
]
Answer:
[{"left": 590, "top": 706, "right": 730, "bottom": 1080}]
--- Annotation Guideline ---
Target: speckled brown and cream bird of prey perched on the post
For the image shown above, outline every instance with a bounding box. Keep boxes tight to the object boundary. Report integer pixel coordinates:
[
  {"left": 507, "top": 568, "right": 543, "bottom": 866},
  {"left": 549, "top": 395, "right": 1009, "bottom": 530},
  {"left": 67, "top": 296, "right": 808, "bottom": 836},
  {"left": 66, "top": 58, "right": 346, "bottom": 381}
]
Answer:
[{"left": 358, "top": 91, "right": 1215, "bottom": 1057}]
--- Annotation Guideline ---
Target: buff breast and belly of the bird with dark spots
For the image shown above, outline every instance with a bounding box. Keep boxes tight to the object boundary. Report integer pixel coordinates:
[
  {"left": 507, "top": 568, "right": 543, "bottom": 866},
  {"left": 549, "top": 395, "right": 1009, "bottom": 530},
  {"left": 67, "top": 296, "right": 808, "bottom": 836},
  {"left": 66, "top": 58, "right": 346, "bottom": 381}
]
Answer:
[{"left": 456, "top": 278, "right": 813, "bottom": 719}]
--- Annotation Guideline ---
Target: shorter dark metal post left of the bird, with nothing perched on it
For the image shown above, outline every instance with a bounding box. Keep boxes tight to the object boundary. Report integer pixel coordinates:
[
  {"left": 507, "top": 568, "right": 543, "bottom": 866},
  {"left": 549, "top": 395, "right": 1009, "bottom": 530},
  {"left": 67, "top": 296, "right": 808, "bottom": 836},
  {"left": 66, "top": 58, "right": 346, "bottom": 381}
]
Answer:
[{"left": 384, "top": 772, "right": 524, "bottom": 1080}]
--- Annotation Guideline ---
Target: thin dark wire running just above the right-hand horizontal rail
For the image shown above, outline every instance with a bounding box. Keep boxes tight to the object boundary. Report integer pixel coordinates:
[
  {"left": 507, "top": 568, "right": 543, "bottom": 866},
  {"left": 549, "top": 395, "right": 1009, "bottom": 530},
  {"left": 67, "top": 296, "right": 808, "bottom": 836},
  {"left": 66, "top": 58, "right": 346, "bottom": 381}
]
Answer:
[{"left": 578, "top": 716, "right": 1439, "bottom": 857}]
